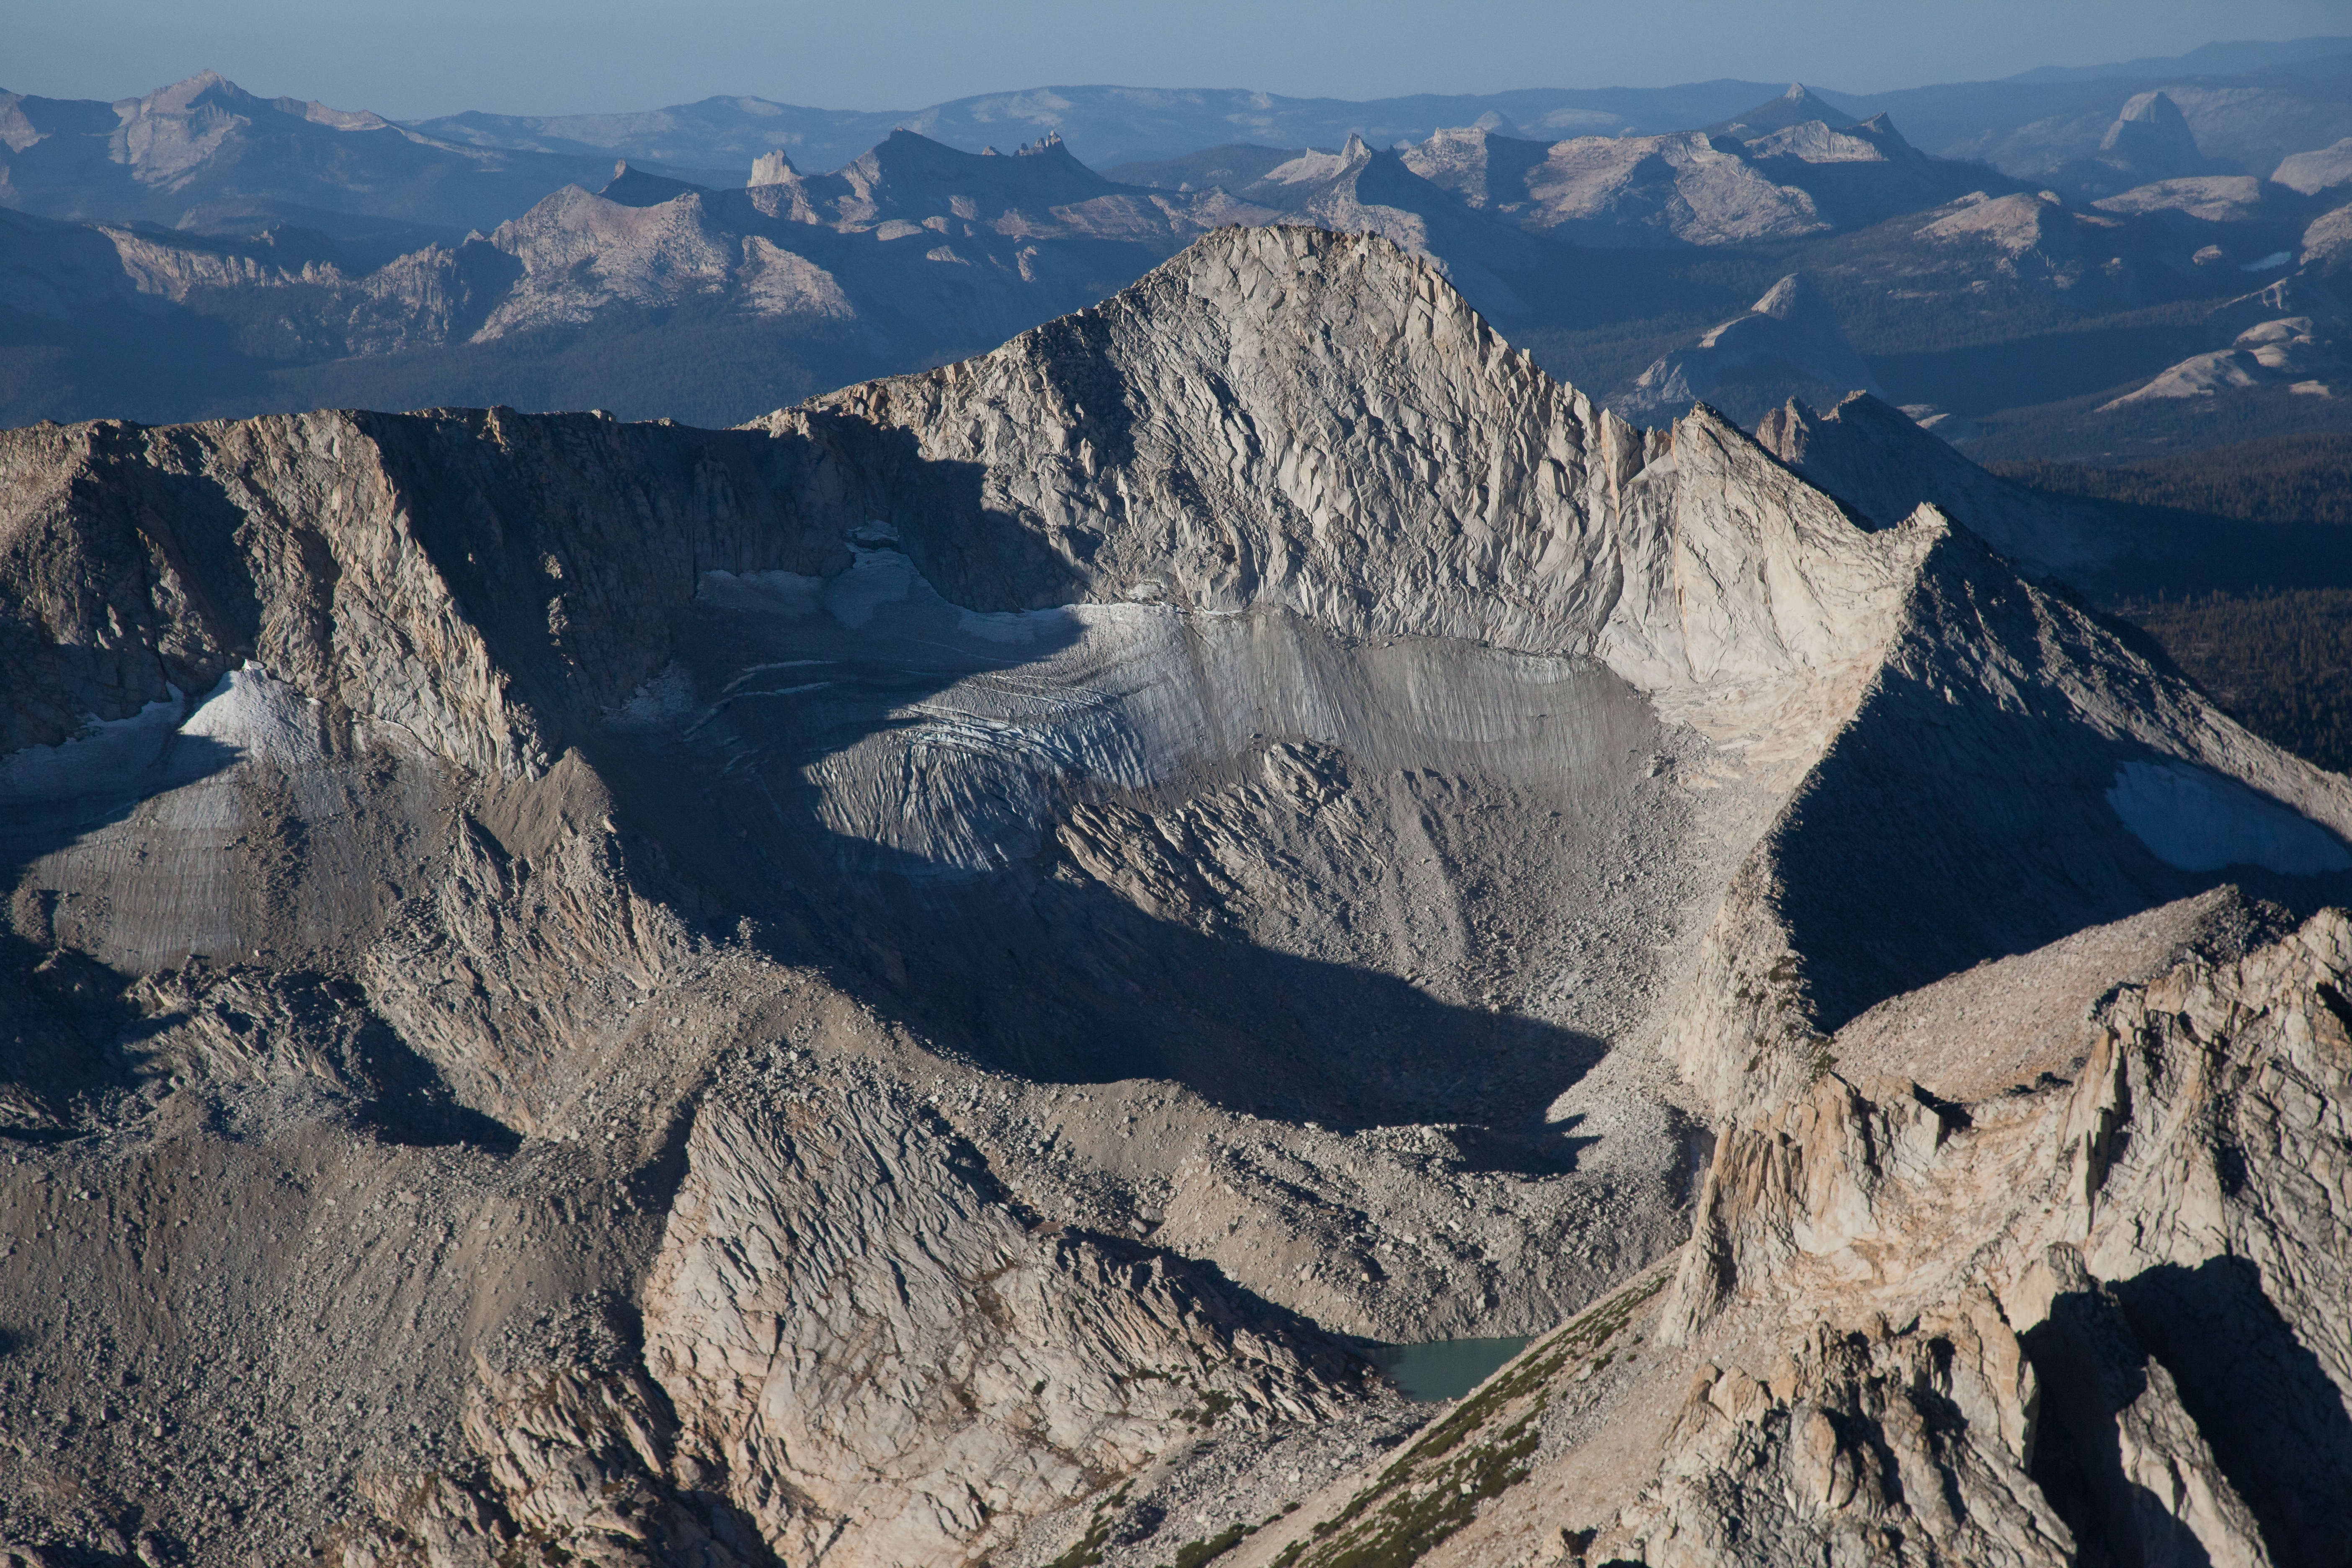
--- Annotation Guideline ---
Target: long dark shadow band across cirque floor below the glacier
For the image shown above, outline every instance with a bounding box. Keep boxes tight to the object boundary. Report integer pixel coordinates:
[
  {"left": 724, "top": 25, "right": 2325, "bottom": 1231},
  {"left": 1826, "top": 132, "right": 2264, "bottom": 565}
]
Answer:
[{"left": 588, "top": 672, "right": 1604, "bottom": 1171}]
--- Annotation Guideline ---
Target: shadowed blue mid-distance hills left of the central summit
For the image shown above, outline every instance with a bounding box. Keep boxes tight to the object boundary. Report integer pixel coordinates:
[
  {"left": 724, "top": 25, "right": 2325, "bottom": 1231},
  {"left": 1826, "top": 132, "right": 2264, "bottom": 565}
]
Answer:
[{"left": 0, "top": 134, "right": 1272, "bottom": 421}]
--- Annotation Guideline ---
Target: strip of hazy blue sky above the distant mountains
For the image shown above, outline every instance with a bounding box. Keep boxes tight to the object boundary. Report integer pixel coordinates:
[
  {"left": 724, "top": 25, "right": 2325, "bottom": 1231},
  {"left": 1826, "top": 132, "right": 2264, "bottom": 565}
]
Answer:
[{"left": 0, "top": 0, "right": 2352, "bottom": 120}]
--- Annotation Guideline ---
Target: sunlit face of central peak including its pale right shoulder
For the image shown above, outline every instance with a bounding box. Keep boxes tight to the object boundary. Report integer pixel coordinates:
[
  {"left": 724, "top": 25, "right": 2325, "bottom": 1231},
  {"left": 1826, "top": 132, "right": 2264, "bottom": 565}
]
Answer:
[{"left": 781, "top": 230, "right": 1903, "bottom": 689}]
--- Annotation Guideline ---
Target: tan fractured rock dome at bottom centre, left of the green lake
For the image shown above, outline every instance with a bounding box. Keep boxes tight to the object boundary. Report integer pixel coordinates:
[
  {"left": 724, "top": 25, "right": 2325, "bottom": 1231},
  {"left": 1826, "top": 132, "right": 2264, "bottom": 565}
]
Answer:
[{"left": 645, "top": 1088, "right": 1362, "bottom": 1563}]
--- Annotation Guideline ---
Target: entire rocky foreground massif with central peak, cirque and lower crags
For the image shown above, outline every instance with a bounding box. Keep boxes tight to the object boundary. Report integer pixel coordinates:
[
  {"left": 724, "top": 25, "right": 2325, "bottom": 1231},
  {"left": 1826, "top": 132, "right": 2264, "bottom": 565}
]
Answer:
[{"left": 0, "top": 227, "right": 2352, "bottom": 1568}]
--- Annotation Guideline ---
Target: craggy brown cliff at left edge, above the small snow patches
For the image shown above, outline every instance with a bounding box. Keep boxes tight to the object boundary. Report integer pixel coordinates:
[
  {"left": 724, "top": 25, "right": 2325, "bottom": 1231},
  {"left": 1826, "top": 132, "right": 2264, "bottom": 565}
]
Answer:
[{"left": 0, "top": 414, "right": 531, "bottom": 769}]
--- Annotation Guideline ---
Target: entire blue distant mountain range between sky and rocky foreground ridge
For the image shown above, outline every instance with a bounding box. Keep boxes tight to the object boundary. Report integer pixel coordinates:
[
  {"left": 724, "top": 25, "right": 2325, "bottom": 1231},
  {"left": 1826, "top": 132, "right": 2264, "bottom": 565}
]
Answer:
[{"left": 13, "top": 40, "right": 2352, "bottom": 456}]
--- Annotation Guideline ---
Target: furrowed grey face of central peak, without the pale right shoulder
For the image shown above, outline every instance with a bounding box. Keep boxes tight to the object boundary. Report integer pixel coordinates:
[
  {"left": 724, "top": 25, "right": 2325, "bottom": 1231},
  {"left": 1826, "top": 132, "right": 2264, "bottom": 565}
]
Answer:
[{"left": 764, "top": 228, "right": 1642, "bottom": 651}]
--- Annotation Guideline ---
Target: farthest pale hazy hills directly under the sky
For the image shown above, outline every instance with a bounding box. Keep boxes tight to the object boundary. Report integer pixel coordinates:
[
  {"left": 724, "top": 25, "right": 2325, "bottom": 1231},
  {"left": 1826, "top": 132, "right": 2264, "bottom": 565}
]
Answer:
[{"left": 18, "top": 40, "right": 2352, "bottom": 237}]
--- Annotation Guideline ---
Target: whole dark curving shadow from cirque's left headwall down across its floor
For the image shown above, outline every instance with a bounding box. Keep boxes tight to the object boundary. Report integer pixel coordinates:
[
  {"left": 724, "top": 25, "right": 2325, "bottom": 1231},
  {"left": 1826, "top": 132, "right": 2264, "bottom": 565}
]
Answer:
[{"left": 353, "top": 411, "right": 1602, "bottom": 1168}]
